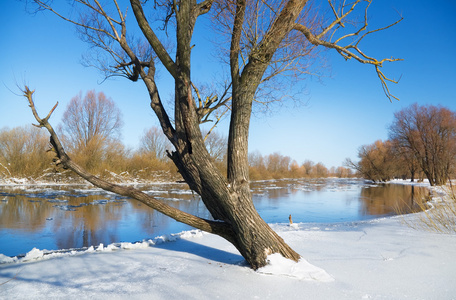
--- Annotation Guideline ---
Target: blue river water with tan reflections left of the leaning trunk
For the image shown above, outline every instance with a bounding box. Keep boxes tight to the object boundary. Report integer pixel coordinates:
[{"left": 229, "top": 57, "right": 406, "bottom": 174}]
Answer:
[{"left": 0, "top": 184, "right": 208, "bottom": 256}]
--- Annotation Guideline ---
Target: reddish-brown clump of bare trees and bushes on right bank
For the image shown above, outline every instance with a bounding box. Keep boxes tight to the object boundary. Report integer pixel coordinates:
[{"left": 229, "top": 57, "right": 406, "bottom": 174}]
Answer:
[{"left": 346, "top": 104, "right": 456, "bottom": 185}]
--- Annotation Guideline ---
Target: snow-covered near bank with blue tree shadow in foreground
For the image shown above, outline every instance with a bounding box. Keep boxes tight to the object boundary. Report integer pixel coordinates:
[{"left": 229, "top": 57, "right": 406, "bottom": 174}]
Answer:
[{"left": 0, "top": 215, "right": 456, "bottom": 299}]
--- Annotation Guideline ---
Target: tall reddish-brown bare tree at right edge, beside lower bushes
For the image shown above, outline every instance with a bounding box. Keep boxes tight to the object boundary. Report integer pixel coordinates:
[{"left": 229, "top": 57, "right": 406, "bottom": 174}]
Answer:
[{"left": 389, "top": 103, "right": 456, "bottom": 185}]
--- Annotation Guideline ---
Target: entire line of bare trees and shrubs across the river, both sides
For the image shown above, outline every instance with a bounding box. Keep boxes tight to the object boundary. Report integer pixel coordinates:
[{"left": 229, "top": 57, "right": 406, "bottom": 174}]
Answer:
[{"left": 7, "top": 91, "right": 456, "bottom": 185}]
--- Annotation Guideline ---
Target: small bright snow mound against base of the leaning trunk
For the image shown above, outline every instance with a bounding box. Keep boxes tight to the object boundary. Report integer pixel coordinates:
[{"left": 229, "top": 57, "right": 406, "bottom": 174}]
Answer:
[{"left": 257, "top": 253, "right": 334, "bottom": 282}]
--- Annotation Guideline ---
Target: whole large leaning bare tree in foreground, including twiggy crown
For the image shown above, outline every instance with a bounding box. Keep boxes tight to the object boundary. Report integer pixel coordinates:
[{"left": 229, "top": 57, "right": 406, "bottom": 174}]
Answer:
[{"left": 24, "top": 0, "right": 399, "bottom": 269}]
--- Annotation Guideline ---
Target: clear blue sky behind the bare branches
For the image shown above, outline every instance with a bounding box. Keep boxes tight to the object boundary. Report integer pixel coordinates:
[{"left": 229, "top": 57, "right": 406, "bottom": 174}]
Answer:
[{"left": 0, "top": 0, "right": 456, "bottom": 168}]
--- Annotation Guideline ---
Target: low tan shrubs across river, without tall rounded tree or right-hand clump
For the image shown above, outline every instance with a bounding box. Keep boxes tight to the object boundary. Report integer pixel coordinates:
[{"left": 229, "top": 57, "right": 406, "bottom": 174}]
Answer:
[{"left": 0, "top": 126, "right": 354, "bottom": 181}]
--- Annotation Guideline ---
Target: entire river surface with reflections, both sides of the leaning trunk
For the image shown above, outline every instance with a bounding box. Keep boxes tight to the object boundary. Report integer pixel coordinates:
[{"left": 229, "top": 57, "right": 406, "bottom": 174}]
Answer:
[{"left": 0, "top": 179, "right": 426, "bottom": 256}]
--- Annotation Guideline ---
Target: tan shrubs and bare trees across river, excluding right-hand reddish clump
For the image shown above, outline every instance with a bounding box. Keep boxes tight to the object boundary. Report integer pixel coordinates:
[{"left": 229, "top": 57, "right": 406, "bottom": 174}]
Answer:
[{"left": 0, "top": 90, "right": 352, "bottom": 181}]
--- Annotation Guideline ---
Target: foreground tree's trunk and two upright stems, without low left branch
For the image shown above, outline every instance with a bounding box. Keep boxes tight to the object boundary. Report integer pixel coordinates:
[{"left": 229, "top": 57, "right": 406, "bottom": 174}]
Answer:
[{"left": 164, "top": 0, "right": 306, "bottom": 269}]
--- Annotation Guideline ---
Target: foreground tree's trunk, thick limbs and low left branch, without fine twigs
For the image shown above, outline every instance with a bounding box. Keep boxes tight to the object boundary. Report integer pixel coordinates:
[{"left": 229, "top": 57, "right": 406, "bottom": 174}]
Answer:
[{"left": 24, "top": 0, "right": 307, "bottom": 269}]
